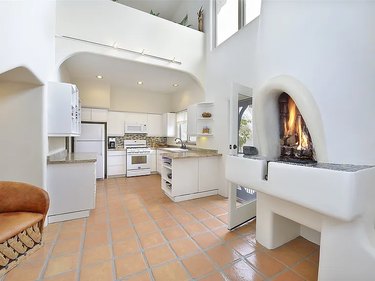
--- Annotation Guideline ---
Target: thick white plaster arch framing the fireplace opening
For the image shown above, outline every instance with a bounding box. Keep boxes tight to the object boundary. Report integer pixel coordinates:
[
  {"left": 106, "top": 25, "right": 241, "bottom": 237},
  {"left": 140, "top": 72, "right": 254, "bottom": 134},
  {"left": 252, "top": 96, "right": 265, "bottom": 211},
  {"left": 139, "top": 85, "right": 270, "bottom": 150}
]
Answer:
[{"left": 254, "top": 75, "right": 328, "bottom": 162}]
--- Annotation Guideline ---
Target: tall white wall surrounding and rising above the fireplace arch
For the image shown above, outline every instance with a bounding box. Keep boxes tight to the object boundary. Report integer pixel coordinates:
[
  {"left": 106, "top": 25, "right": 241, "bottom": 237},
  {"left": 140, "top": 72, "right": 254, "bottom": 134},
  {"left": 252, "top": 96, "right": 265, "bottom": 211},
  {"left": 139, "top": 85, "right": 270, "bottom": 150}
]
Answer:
[{"left": 206, "top": 0, "right": 375, "bottom": 194}]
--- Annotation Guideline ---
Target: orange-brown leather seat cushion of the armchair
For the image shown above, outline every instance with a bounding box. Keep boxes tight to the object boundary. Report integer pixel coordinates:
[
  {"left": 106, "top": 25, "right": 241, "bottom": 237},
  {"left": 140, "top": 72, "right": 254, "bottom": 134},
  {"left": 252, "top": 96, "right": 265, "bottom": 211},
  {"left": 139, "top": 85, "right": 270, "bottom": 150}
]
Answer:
[{"left": 0, "top": 212, "right": 43, "bottom": 243}]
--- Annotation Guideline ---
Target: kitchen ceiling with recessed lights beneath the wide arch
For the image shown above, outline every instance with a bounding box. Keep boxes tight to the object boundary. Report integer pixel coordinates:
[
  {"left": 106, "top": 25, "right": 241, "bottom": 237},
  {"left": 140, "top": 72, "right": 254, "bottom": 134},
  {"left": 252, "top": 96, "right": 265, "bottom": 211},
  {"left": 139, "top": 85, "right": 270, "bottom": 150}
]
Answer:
[{"left": 64, "top": 54, "right": 197, "bottom": 93}]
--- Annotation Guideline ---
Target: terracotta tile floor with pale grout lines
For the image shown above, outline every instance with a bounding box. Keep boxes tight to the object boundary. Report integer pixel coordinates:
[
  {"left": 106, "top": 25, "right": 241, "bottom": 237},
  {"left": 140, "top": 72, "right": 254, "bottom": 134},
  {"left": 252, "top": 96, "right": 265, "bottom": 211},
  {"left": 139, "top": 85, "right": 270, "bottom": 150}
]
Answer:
[{"left": 0, "top": 175, "right": 319, "bottom": 281}]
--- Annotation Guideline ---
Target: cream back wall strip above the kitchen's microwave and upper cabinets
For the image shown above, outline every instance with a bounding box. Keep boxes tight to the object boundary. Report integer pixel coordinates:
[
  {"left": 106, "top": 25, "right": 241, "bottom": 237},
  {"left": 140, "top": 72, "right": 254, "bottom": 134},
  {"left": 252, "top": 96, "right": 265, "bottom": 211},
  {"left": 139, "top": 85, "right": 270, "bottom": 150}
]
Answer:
[{"left": 110, "top": 85, "right": 173, "bottom": 113}]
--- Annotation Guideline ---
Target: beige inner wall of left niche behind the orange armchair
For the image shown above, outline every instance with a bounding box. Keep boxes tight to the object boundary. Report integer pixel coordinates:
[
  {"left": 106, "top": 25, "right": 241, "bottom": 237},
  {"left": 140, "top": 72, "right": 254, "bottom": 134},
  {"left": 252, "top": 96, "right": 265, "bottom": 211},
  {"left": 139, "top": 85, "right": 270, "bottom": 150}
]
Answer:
[{"left": 0, "top": 81, "right": 46, "bottom": 186}]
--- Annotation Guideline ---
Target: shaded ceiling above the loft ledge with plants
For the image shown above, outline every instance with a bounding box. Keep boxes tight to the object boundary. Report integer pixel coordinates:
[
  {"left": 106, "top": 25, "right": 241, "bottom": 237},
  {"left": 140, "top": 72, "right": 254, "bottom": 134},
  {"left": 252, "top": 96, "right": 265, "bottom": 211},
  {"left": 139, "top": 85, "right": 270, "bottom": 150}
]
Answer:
[{"left": 115, "top": 0, "right": 184, "bottom": 21}]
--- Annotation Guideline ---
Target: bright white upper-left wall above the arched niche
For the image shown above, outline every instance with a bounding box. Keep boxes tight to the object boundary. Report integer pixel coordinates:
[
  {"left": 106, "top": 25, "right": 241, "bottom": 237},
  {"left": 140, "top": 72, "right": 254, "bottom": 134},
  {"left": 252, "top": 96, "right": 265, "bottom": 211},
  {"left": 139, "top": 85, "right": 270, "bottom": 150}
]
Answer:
[{"left": 0, "top": 0, "right": 55, "bottom": 81}]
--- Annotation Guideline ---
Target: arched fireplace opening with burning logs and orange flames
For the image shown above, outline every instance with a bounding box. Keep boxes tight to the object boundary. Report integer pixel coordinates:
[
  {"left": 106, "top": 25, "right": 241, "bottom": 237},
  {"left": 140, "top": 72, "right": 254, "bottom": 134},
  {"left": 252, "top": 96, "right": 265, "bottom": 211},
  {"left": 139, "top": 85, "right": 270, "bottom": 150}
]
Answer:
[{"left": 279, "top": 93, "right": 316, "bottom": 164}]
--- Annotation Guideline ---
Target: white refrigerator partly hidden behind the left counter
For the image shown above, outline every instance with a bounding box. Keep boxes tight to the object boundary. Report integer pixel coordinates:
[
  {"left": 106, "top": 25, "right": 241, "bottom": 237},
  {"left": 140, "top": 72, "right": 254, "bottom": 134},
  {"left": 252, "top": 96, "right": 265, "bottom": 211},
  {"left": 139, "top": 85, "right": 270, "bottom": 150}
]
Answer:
[{"left": 74, "top": 123, "right": 105, "bottom": 179}]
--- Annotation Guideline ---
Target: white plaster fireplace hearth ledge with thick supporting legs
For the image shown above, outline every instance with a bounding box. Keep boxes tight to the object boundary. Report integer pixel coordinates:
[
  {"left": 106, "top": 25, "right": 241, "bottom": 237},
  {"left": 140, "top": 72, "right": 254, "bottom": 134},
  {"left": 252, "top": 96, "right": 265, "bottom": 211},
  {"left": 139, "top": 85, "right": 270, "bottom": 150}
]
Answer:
[{"left": 226, "top": 156, "right": 375, "bottom": 281}]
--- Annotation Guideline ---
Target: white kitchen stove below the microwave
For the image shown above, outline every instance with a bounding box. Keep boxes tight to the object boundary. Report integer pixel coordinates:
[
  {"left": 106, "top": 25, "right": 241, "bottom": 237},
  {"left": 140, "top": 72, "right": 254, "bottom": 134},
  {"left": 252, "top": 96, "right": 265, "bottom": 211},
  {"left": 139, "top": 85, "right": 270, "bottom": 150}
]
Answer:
[{"left": 124, "top": 140, "right": 151, "bottom": 177}]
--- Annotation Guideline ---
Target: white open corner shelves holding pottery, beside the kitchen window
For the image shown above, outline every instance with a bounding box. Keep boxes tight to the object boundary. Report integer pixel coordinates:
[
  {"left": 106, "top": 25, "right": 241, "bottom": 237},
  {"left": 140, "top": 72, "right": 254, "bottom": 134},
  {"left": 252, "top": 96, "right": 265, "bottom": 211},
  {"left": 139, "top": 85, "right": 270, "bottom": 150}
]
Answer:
[{"left": 187, "top": 102, "right": 214, "bottom": 136}]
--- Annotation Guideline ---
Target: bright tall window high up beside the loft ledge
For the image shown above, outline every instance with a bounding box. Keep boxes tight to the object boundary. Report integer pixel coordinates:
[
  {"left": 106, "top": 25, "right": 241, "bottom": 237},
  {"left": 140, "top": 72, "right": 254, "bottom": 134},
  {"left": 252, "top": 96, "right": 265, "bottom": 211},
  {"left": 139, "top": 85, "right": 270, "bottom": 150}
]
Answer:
[{"left": 215, "top": 0, "right": 262, "bottom": 46}]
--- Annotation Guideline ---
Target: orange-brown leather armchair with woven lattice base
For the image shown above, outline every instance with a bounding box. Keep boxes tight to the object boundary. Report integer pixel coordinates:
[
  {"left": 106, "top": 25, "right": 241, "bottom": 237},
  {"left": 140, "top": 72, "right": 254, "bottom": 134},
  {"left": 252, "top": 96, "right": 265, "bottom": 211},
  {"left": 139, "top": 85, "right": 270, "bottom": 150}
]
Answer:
[{"left": 0, "top": 181, "right": 49, "bottom": 278}]
